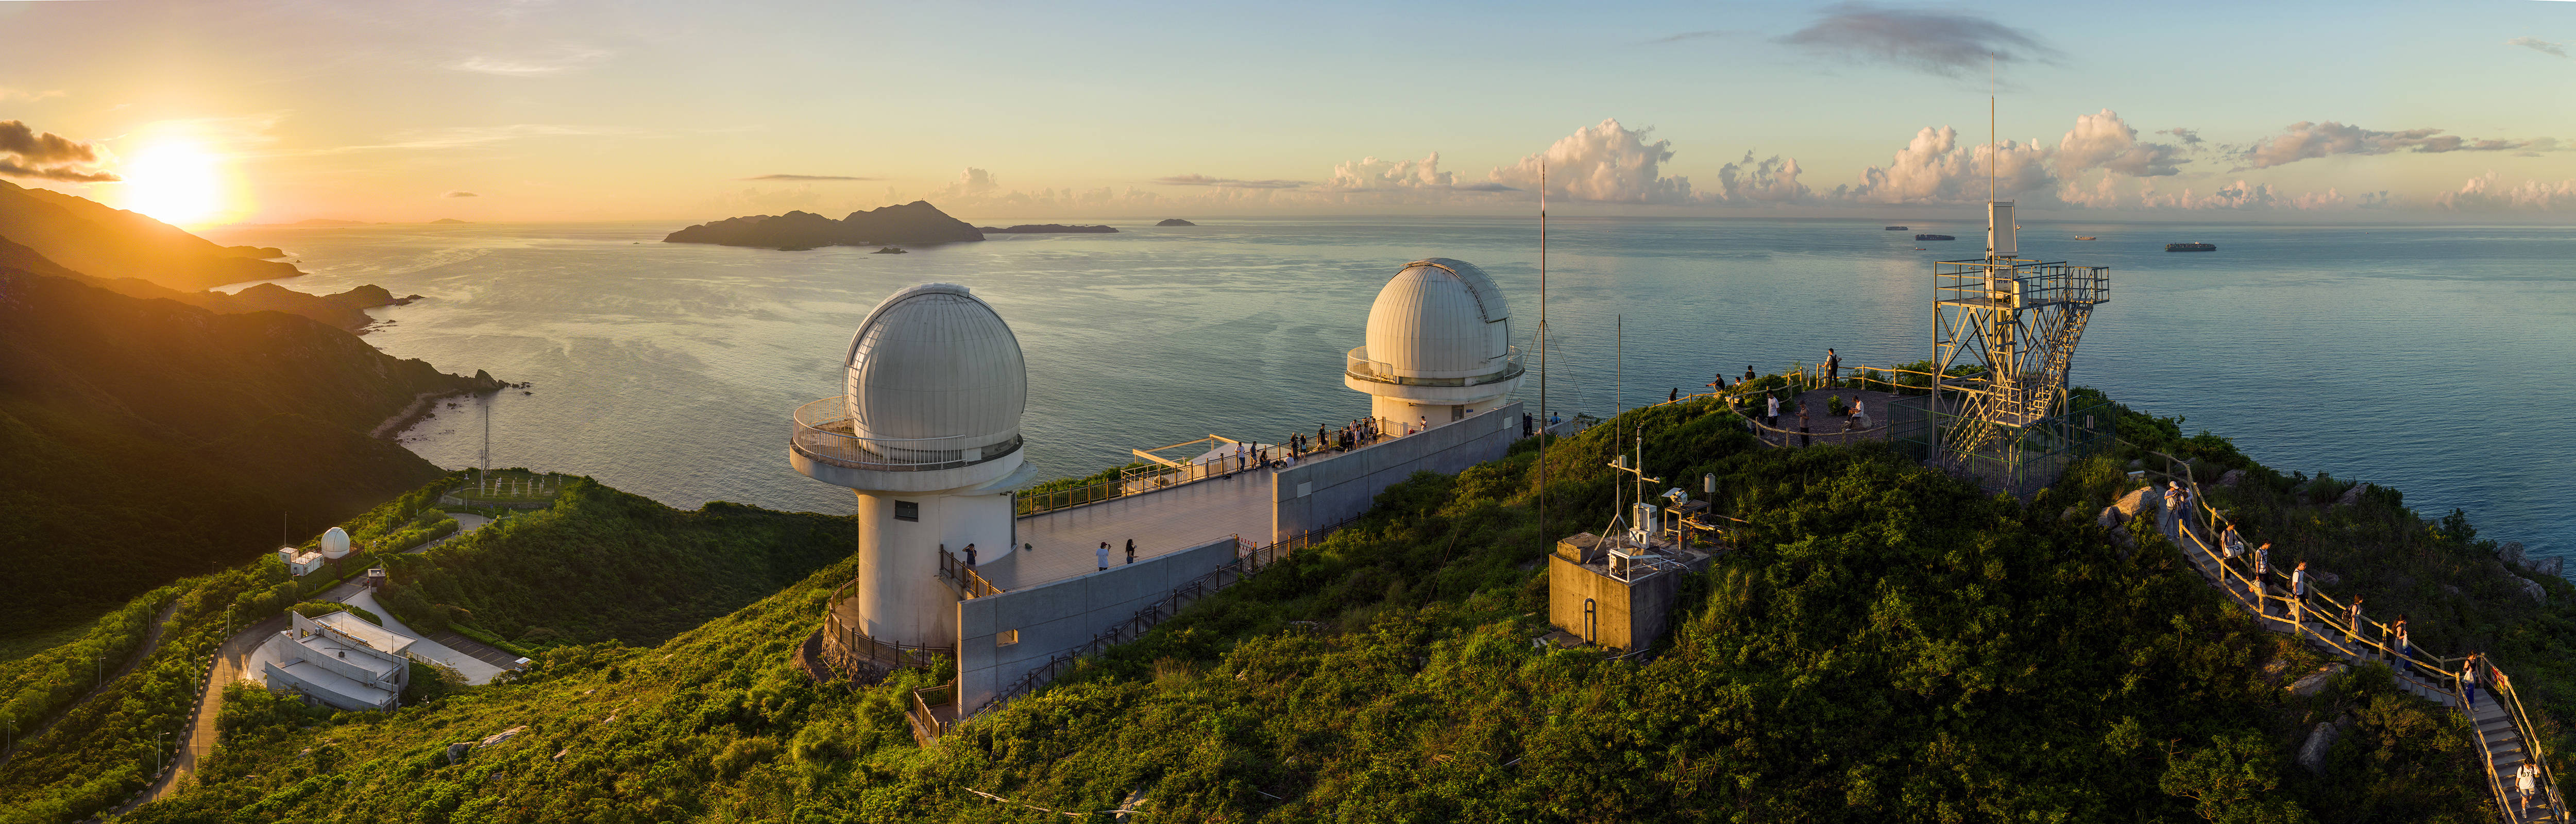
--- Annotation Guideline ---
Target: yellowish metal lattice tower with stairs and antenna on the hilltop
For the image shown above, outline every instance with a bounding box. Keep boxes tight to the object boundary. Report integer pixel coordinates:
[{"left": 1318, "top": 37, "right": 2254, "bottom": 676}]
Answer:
[{"left": 1906, "top": 74, "right": 2110, "bottom": 494}]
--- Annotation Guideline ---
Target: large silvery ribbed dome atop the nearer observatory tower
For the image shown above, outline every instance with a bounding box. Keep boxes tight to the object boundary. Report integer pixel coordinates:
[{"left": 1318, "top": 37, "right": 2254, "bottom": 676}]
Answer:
[{"left": 842, "top": 283, "right": 1028, "bottom": 461}]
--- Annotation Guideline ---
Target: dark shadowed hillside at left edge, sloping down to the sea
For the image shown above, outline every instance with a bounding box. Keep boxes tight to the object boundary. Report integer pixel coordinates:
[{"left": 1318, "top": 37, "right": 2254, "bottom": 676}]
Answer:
[{"left": 0, "top": 270, "right": 497, "bottom": 636}]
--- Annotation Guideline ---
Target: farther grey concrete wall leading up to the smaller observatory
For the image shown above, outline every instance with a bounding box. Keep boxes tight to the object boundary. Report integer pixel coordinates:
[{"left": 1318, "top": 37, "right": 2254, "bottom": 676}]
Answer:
[{"left": 1270, "top": 402, "right": 1520, "bottom": 538}]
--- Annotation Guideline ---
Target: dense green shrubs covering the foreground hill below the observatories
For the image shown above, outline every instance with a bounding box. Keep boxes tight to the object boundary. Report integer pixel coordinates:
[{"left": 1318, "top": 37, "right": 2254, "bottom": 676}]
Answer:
[{"left": 95, "top": 391, "right": 2535, "bottom": 821}]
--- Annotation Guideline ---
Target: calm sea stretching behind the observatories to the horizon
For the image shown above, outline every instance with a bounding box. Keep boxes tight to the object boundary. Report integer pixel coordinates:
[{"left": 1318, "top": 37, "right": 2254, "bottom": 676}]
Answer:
[{"left": 206, "top": 216, "right": 2576, "bottom": 564}]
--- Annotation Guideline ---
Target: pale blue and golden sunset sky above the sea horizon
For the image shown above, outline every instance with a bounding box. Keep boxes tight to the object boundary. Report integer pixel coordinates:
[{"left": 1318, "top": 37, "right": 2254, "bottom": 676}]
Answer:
[{"left": 0, "top": 0, "right": 2576, "bottom": 221}]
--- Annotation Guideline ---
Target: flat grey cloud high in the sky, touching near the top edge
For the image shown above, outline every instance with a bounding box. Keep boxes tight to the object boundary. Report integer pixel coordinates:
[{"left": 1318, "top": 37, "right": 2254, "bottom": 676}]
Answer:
[{"left": 1780, "top": 3, "right": 2058, "bottom": 77}]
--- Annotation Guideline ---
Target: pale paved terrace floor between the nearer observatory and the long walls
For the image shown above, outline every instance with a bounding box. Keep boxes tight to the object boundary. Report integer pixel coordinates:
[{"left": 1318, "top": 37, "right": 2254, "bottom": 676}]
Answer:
[{"left": 981, "top": 469, "right": 1273, "bottom": 590}]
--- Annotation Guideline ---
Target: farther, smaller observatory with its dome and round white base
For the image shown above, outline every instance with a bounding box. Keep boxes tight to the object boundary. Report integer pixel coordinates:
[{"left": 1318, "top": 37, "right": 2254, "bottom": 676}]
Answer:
[{"left": 1342, "top": 258, "right": 1522, "bottom": 433}]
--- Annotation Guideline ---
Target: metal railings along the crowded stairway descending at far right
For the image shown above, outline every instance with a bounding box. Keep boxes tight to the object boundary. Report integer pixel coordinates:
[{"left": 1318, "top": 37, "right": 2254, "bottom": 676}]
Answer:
[{"left": 2146, "top": 451, "right": 2568, "bottom": 821}]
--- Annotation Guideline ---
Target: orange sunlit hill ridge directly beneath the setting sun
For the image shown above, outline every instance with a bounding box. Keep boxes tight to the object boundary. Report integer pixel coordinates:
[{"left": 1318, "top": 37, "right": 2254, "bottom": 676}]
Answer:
[{"left": 0, "top": 180, "right": 301, "bottom": 291}]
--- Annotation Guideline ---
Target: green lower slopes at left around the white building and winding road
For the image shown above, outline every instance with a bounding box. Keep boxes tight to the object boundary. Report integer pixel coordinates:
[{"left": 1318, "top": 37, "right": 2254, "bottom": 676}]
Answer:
[{"left": 0, "top": 474, "right": 855, "bottom": 824}]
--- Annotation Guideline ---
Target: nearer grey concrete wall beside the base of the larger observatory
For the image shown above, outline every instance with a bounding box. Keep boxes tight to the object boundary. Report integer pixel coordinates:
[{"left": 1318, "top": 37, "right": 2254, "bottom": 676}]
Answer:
[{"left": 958, "top": 536, "right": 1234, "bottom": 713}]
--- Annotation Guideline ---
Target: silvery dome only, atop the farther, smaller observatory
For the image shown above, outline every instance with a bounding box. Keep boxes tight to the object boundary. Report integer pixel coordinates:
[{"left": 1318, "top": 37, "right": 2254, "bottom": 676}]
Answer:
[{"left": 1355, "top": 258, "right": 1512, "bottom": 379}]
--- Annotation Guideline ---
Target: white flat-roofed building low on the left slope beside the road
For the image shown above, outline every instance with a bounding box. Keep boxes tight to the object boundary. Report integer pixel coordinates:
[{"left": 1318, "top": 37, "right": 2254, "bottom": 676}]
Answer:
[{"left": 242, "top": 613, "right": 412, "bottom": 711}]
